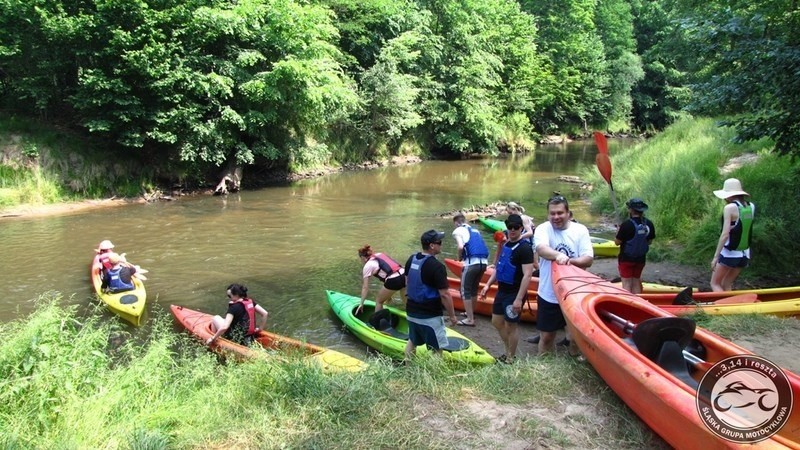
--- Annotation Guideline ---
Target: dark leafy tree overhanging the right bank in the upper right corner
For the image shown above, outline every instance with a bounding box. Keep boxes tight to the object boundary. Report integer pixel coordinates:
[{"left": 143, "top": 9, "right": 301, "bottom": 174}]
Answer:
[{"left": 678, "top": 0, "right": 800, "bottom": 153}]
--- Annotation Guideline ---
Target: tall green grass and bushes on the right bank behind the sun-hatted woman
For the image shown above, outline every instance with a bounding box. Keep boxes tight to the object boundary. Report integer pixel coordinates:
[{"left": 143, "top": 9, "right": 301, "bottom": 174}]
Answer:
[{"left": 586, "top": 118, "right": 800, "bottom": 282}]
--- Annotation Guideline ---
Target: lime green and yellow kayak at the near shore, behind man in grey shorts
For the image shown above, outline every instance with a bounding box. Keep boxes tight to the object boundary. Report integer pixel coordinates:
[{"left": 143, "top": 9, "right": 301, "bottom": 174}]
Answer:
[{"left": 325, "top": 291, "right": 494, "bottom": 364}]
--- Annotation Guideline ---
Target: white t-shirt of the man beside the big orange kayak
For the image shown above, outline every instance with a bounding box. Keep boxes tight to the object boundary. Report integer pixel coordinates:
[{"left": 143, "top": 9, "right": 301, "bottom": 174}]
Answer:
[{"left": 533, "top": 221, "right": 594, "bottom": 303}]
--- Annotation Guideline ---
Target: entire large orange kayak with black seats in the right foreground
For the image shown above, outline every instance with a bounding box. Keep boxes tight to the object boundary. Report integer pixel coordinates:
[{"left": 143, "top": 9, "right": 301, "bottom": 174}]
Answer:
[{"left": 553, "top": 265, "right": 800, "bottom": 449}]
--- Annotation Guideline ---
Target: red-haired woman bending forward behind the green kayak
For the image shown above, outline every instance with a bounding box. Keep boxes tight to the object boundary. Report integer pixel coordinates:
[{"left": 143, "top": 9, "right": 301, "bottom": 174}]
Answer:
[{"left": 356, "top": 245, "right": 406, "bottom": 314}]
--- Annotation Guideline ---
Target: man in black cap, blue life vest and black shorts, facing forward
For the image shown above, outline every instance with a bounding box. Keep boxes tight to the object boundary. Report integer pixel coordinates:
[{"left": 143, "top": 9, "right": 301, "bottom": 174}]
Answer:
[{"left": 480, "top": 214, "right": 533, "bottom": 364}]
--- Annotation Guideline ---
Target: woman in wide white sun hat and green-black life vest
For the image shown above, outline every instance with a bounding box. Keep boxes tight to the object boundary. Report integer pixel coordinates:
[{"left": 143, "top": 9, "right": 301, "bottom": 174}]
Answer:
[{"left": 711, "top": 178, "right": 756, "bottom": 291}]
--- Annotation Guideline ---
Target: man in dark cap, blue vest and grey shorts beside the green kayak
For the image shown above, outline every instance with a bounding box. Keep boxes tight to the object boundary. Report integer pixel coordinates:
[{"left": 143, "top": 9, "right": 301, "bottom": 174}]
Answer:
[{"left": 405, "top": 230, "right": 456, "bottom": 360}]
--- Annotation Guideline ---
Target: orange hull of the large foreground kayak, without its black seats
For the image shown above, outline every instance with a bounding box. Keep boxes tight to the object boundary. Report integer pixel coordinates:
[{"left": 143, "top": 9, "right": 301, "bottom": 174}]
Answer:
[{"left": 553, "top": 265, "right": 800, "bottom": 449}]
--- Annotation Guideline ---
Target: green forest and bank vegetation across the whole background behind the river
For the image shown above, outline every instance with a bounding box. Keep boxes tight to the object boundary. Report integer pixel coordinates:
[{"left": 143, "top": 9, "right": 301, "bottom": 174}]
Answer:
[{"left": 0, "top": 0, "right": 800, "bottom": 282}]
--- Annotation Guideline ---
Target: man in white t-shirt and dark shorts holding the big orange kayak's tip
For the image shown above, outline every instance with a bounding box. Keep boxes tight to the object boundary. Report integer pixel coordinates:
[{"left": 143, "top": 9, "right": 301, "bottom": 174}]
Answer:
[{"left": 533, "top": 195, "right": 594, "bottom": 355}]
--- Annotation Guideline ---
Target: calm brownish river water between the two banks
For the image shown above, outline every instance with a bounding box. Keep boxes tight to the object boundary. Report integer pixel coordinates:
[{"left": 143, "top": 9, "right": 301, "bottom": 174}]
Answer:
[{"left": 0, "top": 142, "right": 620, "bottom": 353}]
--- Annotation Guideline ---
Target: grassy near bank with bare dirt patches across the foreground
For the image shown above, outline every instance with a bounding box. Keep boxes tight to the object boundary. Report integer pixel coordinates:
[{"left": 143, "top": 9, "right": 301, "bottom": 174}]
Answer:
[{"left": 0, "top": 293, "right": 660, "bottom": 449}]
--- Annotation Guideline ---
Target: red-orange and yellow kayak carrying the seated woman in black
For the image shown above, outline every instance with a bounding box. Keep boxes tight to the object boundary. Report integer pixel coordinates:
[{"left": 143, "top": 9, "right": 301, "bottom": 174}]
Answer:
[{"left": 169, "top": 305, "right": 367, "bottom": 372}]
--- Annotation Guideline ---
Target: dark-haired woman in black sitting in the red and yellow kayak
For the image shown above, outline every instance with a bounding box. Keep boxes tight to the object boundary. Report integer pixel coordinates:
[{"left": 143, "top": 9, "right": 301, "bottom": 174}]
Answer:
[{"left": 206, "top": 284, "right": 269, "bottom": 345}]
